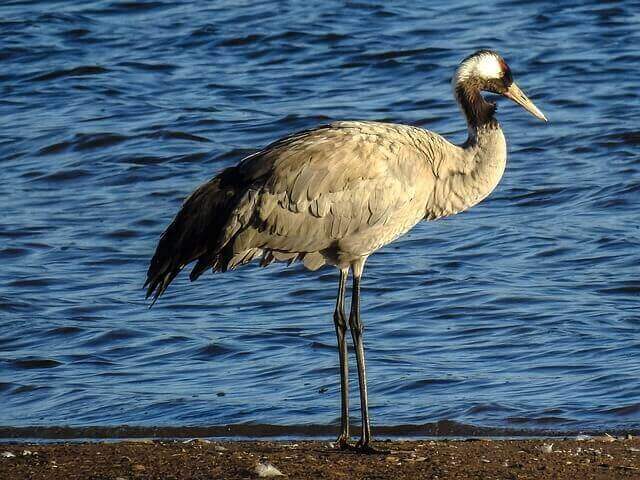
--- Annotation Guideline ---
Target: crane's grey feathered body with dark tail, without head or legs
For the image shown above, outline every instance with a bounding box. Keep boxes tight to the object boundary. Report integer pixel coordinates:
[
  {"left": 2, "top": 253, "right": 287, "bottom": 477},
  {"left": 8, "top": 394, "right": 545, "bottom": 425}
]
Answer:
[{"left": 145, "top": 122, "right": 506, "bottom": 295}]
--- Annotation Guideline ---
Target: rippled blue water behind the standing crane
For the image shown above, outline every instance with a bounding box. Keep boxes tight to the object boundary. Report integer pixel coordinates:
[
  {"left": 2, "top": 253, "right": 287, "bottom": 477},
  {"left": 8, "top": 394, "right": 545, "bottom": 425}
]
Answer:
[{"left": 0, "top": 0, "right": 640, "bottom": 430}]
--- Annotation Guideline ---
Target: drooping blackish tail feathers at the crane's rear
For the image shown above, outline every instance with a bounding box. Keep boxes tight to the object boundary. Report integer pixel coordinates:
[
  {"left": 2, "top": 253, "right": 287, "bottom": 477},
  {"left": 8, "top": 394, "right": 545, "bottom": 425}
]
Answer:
[{"left": 144, "top": 167, "right": 243, "bottom": 307}]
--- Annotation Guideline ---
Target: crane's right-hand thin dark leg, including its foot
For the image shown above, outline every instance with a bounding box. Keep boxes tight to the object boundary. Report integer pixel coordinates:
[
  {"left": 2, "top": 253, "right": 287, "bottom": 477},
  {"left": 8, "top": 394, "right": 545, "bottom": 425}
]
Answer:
[{"left": 349, "top": 259, "right": 384, "bottom": 453}]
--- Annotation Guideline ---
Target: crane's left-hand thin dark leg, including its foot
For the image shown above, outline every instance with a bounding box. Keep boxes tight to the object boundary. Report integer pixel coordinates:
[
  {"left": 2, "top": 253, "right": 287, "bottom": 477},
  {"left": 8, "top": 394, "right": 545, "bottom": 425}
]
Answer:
[{"left": 333, "top": 268, "right": 349, "bottom": 450}]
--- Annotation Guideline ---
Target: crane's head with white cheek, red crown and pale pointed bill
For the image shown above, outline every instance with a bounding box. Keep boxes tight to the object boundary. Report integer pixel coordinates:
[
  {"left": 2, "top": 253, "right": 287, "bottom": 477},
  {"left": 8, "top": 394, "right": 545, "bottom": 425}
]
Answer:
[{"left": 453, "top": 50, "right": 547, "bottom": 122}]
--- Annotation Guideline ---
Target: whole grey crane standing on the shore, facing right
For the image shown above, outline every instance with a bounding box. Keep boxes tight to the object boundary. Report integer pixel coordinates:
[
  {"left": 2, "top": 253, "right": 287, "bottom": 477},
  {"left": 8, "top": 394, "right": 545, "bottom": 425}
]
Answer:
[{"left": 145, "top": 50, "right": 547, "bottom": 453}]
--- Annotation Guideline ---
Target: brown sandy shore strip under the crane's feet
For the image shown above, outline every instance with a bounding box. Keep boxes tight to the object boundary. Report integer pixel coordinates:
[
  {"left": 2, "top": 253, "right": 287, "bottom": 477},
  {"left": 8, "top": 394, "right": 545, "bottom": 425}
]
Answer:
[{"left": 0, "top": 437, "right": 640, "bottom": 480}]
